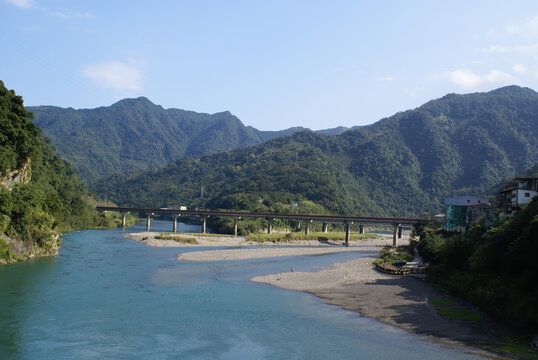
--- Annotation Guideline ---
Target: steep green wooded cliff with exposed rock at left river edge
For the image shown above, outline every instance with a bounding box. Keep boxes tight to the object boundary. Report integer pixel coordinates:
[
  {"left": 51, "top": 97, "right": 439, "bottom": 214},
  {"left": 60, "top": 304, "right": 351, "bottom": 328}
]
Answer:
[{"left": 0, "top": 81, "right": 118, "bottom": 262}]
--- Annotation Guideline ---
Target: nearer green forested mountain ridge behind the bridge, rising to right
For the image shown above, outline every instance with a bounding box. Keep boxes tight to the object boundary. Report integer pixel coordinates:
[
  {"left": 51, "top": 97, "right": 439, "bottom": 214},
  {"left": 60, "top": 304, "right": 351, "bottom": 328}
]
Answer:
[{"left": 94, "top": 86, "right": 538, "bottom": 216}]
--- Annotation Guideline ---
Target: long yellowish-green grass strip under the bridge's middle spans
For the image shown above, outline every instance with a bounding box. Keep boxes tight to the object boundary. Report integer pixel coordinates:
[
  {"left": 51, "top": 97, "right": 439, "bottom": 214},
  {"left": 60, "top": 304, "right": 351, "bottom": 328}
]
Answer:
[{"left": 245, "top": 232, "right": 381, "bottom": 243}]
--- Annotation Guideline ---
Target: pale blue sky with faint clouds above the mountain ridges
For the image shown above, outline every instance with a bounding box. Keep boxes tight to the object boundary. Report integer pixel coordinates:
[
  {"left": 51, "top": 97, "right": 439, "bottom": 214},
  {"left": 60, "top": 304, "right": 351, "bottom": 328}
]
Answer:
[{"left": 0, "top": 0, "right": 538, "bottom": 130}]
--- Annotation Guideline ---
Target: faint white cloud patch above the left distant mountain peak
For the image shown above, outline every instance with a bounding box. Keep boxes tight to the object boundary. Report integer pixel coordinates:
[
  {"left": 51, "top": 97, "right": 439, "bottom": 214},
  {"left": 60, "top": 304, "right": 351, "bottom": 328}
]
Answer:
[{"left": 82, "top": 61, "right": 142, "bottom": 90}]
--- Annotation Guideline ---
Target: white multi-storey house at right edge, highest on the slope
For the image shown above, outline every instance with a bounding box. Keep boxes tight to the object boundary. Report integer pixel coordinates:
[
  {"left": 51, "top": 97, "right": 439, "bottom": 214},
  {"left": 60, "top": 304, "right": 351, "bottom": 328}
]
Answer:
[{"left": 497, "top": 177, "right": 538, "bottom": 216}]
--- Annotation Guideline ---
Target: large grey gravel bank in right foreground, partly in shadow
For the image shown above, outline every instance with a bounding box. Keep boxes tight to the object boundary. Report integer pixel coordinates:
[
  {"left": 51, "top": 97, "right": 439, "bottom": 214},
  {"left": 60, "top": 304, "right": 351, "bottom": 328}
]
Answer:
[{"left": 251, "top": 257, "right": 506, "bottom": 358}]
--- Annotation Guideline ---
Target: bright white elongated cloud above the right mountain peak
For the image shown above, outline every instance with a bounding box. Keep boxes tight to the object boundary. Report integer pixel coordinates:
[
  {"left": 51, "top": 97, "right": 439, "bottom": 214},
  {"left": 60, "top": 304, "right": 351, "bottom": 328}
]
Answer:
[{"left": 434, "top": 69, "right": 519, "bottom": 90}]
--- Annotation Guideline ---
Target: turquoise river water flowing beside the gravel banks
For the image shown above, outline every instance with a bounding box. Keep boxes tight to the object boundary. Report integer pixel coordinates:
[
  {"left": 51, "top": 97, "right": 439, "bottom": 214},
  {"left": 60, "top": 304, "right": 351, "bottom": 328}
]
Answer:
[{"left": 0, "top": 221, "right": 484, "bottom": 360}]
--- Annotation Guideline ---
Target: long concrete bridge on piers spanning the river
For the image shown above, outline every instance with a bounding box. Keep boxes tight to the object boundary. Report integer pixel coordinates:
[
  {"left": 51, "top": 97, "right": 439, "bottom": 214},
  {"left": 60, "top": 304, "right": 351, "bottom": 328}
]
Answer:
[{"left": 97, "top": 206, "right": 439, "bottom": 246}]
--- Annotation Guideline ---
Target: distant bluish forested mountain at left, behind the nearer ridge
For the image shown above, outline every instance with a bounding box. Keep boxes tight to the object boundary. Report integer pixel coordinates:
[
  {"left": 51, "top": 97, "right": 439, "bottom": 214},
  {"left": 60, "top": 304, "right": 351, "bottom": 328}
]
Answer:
[{"left": 28, "top": 97, "right": 347, "bottom": 184}]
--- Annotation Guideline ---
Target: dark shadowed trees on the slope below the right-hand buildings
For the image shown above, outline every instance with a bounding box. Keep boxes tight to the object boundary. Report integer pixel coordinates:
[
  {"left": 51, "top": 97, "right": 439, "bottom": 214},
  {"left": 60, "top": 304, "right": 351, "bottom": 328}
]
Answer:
[{"left": 417, "top": 197, "right": 538, "bottom": 334}]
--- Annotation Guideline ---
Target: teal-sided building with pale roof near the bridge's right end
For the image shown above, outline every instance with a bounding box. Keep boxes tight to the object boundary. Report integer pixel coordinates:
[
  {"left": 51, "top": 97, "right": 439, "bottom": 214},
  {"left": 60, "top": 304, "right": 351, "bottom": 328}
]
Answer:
[{"left": 445, "top": 196, "right": 490, "bottom": 232}]
